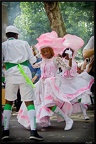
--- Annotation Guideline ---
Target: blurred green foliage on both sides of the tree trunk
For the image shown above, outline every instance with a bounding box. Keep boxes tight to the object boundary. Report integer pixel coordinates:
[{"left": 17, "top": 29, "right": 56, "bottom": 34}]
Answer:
[{"left": 5, "top": 2, "right": 94, "bottom": 58}]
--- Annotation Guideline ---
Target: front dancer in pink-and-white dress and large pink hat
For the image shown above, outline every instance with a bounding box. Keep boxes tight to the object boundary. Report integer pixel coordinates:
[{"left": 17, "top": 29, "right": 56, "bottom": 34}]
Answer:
[{"left": 17, "top": 31, "right": 84, "bottom": 130}]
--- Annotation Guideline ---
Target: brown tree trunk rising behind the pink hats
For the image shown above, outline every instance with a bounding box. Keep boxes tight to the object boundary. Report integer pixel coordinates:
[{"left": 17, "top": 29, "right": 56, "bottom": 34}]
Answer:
[{"left": 43, "top": 2, "right": 66, "bottom": 37}]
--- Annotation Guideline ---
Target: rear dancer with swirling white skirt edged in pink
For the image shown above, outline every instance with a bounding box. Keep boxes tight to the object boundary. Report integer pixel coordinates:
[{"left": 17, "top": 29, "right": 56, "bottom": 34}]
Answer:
[{"left": 57, "top": 47, "right": 94, "bottom": 120}]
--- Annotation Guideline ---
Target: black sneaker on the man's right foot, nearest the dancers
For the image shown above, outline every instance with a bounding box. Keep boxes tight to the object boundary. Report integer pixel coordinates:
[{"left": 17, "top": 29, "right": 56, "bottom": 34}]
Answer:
[{"left": 30, "top": 130, "right": 44, "bottom": 141}]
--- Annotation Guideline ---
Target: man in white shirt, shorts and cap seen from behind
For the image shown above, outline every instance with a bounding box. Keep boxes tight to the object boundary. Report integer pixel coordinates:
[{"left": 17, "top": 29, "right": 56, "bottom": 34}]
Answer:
[{"left": 2, "top": 25, "right": 44, "bottom": 141}]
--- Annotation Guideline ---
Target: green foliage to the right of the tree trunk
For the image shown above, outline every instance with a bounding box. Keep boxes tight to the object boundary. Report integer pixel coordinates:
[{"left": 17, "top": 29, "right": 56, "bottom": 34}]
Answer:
[{"left": 59, "top": 2, "right": 94, "bottom": 44}]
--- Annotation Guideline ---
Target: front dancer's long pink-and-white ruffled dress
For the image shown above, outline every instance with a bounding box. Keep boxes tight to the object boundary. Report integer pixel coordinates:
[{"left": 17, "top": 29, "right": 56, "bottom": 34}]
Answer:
[{"left": 17, "top": 57, "right": 72, "bottom": 129}]
